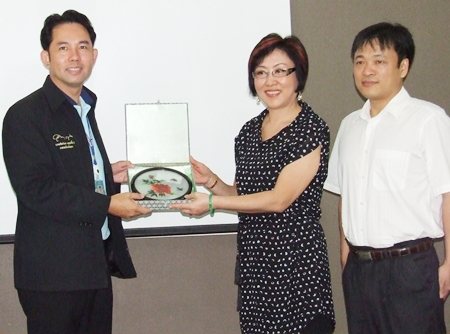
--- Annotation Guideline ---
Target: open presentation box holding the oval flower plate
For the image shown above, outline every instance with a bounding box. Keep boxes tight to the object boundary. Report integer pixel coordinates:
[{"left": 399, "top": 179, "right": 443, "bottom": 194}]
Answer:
[{"left": 125, "top": 103, "right": 196, "bottom": 211}]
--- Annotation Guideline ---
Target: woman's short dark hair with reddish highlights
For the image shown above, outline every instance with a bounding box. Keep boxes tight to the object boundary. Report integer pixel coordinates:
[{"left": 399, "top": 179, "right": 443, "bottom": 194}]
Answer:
[{"left": 248, "top": 34, "right": 309, "bottom": 96}]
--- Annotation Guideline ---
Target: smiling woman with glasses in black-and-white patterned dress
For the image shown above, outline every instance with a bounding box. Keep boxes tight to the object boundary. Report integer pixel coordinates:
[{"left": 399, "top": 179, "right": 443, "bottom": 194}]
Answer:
[{"left": 172, "top": 34, "right": 335, "bottom": 334}]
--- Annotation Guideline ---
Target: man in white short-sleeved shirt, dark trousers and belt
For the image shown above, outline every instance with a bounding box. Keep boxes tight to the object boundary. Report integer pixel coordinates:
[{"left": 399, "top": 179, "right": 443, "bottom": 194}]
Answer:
[{"left": 325, "top": 23, "right": 450, "bottom": 334}]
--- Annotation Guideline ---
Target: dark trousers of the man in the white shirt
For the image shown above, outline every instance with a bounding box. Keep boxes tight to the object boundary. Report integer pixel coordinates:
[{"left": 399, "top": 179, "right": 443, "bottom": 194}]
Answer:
[{"left": 342, "top": 247, "right": 446, "bottom": 334}]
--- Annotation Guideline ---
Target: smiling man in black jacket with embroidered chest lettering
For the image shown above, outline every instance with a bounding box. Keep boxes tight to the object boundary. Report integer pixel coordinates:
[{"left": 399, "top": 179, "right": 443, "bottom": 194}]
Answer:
[{"left": 2, "top": 10, "right": 150, "bottom": 334}]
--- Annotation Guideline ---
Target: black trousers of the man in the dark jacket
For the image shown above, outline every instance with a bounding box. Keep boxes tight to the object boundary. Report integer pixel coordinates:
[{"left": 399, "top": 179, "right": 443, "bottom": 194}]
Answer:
[{"left": 17, "top": 284, "right": 113, "bottom": 334}]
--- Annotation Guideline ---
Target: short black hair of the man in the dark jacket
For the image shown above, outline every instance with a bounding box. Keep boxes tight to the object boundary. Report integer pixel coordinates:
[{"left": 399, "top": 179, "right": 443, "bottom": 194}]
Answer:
[{"left": 41, "top": 9, "right": 97, "bottom": 51}]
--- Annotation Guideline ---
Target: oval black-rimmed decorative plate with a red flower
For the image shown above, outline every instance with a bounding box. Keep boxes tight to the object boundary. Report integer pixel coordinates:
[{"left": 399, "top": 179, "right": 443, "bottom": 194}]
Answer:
[{"left": 131, "top": 167, "right": 192, "bottom": 200}]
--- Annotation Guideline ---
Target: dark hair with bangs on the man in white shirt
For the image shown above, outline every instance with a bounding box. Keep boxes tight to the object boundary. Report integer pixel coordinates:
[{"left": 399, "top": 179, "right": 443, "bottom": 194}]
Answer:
[{"left": 351, "top": 22, "right": 416, "bottom": 68}]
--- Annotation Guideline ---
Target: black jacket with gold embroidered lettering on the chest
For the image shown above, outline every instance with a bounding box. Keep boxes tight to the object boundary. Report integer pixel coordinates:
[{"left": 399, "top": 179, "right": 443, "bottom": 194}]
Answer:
[{"left": 2, "top": 77, "right": 136, "bottom": 291}]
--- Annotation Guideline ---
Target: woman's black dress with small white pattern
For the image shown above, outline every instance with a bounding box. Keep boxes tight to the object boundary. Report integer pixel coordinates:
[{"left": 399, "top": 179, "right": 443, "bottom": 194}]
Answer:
[{"left": 235, "top": 102, "right": 334, "bottom": 334}]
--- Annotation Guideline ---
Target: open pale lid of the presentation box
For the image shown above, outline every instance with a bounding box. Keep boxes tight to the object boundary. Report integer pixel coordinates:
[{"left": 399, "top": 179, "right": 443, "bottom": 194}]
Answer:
[{"left": 125, "top": 103, "right": 189, "bottom": 165}]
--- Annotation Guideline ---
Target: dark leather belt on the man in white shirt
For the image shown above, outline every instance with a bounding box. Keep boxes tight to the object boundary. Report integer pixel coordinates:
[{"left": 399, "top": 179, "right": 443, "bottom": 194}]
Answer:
[{"left": 349, "top": 238, "right": 433, "bottom": 260}]
